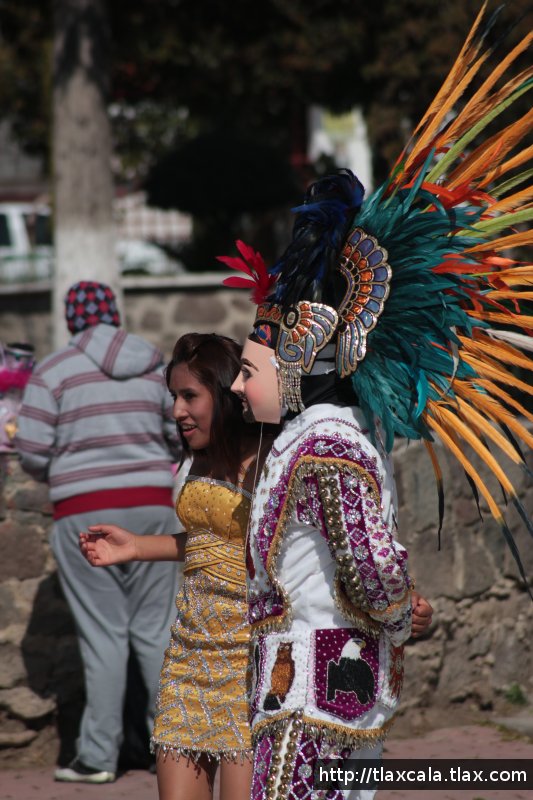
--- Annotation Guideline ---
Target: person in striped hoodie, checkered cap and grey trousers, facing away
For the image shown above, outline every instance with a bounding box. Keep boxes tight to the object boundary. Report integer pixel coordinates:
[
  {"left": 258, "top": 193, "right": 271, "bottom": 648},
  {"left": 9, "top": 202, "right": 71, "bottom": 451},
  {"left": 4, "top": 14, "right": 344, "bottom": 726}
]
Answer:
[{"left": 15, "top": 281, "right": 181, "bottom": 783}]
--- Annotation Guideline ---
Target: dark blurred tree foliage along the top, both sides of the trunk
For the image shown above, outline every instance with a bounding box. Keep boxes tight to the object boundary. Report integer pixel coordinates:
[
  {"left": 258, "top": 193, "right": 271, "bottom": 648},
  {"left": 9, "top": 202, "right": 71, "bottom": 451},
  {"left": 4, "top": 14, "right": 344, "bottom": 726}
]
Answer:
[{"left": 0, "top": 0, "right": 531, "bottom": 193}]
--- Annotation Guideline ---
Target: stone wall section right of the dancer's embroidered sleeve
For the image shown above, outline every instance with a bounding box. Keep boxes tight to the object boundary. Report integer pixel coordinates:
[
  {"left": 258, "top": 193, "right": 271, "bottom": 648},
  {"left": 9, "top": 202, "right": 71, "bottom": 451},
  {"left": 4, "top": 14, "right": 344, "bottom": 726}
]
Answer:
[{"left": 394, "top": 443, "right": 533, "bottom": 731}]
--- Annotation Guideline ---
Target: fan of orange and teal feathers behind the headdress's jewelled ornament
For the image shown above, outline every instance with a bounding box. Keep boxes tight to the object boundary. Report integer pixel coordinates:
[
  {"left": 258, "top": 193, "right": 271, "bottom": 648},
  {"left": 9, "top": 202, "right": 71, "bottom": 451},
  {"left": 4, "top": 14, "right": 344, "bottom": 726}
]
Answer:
[{"left": 353, "top": 3, "right": 533, "bottom": 580}]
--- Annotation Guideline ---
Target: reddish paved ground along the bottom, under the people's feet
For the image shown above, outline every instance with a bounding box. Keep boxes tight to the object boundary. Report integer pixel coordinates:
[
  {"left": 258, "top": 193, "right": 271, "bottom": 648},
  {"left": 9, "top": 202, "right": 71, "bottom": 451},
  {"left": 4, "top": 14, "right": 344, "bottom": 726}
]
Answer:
[{"left": 0, "top": 725, "right": 533, "bottom": 800}]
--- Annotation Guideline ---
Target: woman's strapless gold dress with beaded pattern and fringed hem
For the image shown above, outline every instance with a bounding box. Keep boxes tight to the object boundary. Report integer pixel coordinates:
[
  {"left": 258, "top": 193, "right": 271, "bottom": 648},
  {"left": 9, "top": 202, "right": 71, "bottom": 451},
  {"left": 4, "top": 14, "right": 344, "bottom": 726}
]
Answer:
[{"left": 152, "top": 476, "right": 252, "bottom": 759}]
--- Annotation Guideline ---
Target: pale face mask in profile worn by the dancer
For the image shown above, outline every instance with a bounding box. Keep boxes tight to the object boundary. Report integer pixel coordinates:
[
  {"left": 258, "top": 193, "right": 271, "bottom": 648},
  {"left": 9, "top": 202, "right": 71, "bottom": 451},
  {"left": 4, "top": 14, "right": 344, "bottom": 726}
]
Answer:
[{"left": 231, "top": 339, "right": 281, "bottom": 424}]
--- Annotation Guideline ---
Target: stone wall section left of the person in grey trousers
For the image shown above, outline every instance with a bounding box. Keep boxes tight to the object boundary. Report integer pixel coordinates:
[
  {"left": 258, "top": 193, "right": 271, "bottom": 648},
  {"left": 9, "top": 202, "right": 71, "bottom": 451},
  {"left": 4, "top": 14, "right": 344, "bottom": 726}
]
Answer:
[{"left": 0, "top": 455, "right": 69, "bottom": 765}]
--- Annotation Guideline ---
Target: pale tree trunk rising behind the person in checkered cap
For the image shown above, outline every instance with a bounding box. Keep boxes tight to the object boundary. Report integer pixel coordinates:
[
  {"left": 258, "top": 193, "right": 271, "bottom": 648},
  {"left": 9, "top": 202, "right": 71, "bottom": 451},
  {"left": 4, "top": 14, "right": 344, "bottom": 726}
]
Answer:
[{"left": 52, "top": 0, "right": 120, "bottom": 347}]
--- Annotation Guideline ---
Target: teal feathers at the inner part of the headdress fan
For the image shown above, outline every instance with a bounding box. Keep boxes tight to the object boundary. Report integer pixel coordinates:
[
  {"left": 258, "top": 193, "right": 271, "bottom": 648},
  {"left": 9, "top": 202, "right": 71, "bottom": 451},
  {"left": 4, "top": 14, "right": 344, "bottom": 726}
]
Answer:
[{"left": 352, "top": 174, "right": 492, "bottom": 449}]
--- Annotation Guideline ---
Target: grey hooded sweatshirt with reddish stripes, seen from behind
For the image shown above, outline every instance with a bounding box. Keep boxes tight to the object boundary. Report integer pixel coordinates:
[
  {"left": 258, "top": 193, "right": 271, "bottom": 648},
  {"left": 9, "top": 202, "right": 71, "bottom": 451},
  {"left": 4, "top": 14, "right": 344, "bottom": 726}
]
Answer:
[{"left": 15, "top": 324, "right": 180, "bottom": 505}]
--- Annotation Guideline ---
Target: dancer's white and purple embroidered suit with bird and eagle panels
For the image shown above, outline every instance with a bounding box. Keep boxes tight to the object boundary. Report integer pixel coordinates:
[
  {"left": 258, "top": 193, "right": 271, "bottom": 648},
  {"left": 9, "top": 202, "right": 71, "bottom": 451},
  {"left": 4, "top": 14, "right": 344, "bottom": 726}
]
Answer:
[{"left": 248, "top": 403, "right": 411, "bottom": 798}]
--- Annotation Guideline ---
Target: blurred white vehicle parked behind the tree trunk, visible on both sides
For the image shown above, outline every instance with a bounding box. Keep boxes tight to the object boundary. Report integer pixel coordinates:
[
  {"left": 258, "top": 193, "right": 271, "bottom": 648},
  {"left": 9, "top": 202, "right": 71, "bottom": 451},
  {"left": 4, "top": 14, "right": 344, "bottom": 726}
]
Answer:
[{"left": 0, "top": 203, "right": 185, "bottom": 283}]
